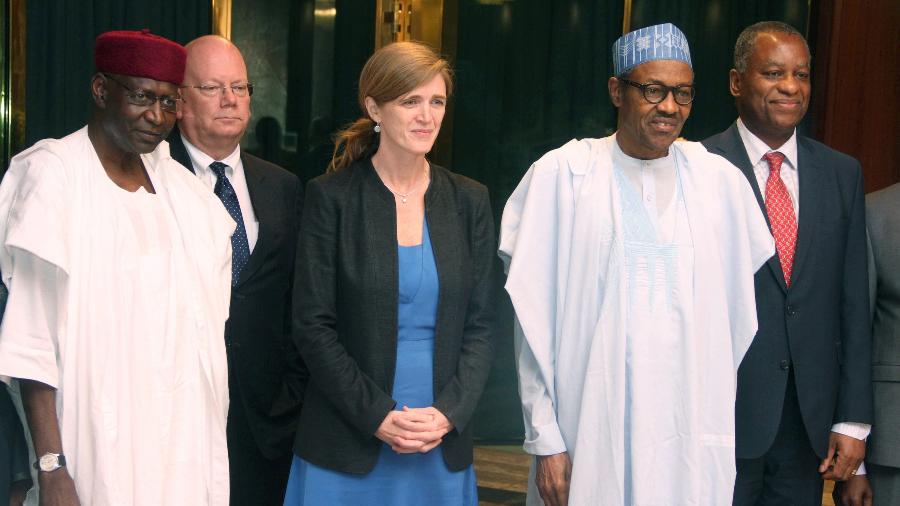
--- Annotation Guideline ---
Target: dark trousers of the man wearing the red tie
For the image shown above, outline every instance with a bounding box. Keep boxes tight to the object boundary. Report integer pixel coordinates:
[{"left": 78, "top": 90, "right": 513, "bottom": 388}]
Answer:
[{"left": 734, "top": 371, "right": 824, "bottom": 506}]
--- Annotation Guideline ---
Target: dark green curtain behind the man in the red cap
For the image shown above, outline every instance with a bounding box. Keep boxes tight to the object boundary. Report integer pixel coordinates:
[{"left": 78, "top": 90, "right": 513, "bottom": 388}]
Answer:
[{"left": 24, "top": 0, "right": 211, "bottom": 147}]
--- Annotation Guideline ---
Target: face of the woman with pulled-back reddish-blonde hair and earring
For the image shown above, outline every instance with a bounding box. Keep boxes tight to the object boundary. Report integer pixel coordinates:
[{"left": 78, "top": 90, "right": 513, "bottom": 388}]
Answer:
[{"left": 366, "top": 75, "right": 447, "bottom": 159}]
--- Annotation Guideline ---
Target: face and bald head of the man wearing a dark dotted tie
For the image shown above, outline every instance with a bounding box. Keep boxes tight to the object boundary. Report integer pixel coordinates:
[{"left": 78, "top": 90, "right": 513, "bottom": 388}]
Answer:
[{"left": 178, "top": 36, "right": 250, "bottom": 160}]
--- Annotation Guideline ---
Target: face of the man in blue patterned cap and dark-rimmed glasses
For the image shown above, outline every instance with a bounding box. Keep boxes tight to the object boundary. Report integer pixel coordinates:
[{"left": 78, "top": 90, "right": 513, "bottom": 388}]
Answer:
[{"left": 607, "top": 60, "right": 694, "bottom": 160}]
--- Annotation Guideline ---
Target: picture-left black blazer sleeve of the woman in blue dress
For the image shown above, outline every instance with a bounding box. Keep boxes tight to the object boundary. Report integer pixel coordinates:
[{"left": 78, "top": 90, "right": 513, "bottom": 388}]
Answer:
[{"left": 294, "top": 180, "right": 395, "bottom": 434}]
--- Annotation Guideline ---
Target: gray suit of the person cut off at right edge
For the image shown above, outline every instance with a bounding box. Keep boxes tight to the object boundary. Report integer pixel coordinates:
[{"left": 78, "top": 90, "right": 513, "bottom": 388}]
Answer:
[{"left": 866, "top": 184, "right": 900, "bottom": 505}]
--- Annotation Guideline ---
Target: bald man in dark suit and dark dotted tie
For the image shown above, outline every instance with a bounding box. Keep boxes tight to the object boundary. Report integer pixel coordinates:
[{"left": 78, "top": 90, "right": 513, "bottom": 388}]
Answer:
[{"left": 169, "top": 36, "right": 305, "bottom": 506}]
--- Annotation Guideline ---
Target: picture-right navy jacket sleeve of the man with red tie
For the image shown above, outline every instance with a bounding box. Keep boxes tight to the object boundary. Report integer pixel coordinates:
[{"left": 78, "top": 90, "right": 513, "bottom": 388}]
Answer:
[{"left": 834, "top": 163, "right": 872, "bottom": 423}]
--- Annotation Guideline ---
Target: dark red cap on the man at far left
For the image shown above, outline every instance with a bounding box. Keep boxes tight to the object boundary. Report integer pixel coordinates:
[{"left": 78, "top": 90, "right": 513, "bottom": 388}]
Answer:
[{"left": 94, "top": 28, "right": 187, "bottom": 85}]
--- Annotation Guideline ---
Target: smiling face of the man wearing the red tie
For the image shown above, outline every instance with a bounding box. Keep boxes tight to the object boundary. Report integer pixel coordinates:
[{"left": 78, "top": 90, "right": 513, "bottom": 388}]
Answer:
[{"left": 729, "top": 33, "right": 810, "bottom": 149}]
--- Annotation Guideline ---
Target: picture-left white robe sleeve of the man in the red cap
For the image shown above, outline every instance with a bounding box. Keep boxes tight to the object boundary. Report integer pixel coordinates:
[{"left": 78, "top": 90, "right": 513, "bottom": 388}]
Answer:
[{"left": 0, "top": 141, "right": 68, "bottom": 388}]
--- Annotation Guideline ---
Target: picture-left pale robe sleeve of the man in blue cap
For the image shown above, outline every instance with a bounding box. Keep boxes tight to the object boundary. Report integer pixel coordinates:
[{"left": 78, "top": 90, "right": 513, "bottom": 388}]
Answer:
[{"left": 499, "top": 140, "right": 590, "bottom": 455}]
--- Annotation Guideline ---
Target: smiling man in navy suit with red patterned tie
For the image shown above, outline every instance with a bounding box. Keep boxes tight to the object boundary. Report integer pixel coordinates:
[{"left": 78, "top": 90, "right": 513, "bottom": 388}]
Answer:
[{"left": 704, "top": 22, "right": 872, "bottom": 506}]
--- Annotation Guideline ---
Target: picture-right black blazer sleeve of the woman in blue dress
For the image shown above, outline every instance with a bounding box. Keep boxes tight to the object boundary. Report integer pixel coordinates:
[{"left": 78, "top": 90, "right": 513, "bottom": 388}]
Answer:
[{"left": 434, "top": 189, "right": 497, "bottom": 432}]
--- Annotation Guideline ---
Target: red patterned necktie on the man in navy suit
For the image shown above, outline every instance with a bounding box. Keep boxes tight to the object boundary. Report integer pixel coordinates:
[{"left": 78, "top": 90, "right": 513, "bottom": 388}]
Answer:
[{"left": 763, "top": 151, "right": 797, "bottom": 288}]
